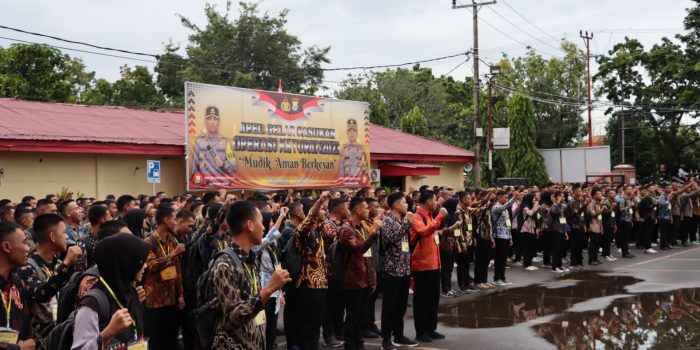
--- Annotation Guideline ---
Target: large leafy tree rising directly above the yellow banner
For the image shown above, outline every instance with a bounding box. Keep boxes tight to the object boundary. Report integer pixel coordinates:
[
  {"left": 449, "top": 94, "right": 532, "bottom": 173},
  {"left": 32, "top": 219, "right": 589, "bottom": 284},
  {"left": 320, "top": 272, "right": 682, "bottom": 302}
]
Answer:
[{"left": 172, "top": 1, "right": 330, "bottom": 96}]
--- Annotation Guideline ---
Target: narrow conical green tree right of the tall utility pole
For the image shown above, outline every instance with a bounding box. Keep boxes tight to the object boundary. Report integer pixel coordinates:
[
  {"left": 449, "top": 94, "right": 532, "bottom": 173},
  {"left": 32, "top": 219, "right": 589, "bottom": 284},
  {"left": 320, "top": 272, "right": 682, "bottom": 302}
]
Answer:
[{"left": 505, "top": 95, "right": 548, "bottom": 185}]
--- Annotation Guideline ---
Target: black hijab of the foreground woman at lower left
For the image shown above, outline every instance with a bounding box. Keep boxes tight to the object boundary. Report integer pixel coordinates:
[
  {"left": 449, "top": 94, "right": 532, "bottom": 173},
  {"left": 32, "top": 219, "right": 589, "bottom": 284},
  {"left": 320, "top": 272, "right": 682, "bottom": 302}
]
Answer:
[{"left": 95, "top": 234, "right": 151, "bottom": 342}]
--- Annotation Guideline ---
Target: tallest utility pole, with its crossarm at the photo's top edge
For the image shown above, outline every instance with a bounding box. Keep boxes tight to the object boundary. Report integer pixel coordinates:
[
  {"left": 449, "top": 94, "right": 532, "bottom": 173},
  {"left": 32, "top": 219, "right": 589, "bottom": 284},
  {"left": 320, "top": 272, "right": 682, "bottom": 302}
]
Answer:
[{"left": 452, "top": 0, "right": 496, "bottom": 187}]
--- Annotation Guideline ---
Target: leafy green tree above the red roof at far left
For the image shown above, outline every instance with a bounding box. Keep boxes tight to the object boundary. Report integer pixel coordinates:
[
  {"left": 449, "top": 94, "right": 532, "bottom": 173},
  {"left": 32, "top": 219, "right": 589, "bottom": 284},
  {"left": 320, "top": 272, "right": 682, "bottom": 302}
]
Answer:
[{"left": 0, "top": 44, "right": 75, "bottom": 102}]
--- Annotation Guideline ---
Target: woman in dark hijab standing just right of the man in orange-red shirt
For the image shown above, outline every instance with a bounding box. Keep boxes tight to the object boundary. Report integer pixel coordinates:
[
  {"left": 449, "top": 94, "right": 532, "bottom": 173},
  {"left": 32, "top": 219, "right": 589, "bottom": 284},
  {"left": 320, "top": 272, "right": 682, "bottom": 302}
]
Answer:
[{"left": 440, "top": 197, "right": 461, "bottom": 297}]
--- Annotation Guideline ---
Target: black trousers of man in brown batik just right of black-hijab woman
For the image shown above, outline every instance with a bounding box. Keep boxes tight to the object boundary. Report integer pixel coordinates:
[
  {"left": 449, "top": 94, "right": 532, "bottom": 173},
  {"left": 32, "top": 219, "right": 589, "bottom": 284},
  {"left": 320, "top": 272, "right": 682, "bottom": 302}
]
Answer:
[{"left": 143, "top": 306, "right": 180, "bottom": 350}]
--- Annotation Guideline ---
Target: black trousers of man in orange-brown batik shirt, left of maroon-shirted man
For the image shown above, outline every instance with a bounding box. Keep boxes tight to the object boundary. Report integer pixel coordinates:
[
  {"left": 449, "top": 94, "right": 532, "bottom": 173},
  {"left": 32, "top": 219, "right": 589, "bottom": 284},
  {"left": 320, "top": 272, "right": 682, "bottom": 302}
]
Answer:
[{"left": 284, "top": 288, "right": 326, "bottom": 350}]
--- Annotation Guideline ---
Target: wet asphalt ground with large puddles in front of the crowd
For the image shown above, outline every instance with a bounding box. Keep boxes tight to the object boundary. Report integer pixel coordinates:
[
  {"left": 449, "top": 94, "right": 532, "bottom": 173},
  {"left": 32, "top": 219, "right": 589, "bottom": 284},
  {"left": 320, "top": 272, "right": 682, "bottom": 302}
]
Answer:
[{"left": 278, "top": 246, "right": 700, "bottom": 350}]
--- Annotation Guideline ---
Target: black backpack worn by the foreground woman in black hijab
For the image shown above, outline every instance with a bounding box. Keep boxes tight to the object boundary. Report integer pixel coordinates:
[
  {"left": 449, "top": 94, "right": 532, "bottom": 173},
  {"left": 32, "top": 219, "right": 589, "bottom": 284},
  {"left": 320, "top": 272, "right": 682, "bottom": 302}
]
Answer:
[{"left": 46, "top": 289, "right": 112, "bottom": 350}]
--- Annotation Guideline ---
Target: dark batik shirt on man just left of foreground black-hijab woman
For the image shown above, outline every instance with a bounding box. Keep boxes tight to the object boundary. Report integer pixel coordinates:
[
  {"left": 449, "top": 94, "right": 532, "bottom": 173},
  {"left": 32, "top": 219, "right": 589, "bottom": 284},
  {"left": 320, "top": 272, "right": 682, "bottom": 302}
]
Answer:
[{"left": 17, "top": 252, "right": 73, "bottom": 349}]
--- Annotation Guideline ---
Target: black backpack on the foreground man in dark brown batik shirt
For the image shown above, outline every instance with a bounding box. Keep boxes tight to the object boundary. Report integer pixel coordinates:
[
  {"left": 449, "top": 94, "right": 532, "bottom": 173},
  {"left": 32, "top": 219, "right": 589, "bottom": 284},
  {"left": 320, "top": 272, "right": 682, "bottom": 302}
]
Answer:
[{"left": 191, "top": 248, "right": 242, "bottom": 349}]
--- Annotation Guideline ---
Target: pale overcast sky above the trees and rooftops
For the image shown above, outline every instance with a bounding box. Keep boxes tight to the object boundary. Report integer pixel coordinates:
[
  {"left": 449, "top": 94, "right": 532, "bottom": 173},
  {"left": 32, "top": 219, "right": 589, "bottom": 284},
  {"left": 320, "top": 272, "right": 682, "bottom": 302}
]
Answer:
[{"left": 0, "top": 0, "right": 693, "bottom": 135}]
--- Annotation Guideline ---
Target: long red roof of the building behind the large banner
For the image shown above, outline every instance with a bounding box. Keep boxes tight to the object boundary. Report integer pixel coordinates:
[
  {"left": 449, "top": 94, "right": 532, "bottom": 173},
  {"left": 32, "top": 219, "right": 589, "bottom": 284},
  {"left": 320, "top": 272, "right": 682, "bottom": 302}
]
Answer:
[{"left": 0, "top": 98, "right": 474, "bottom": 163}]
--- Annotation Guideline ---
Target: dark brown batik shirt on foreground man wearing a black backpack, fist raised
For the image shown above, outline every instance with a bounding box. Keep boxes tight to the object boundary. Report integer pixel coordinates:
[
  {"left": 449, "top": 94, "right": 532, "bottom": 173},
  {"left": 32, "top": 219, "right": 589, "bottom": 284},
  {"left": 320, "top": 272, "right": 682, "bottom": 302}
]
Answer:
[{"left": 212, "top": 244, "right": 266, "bottom": 350}]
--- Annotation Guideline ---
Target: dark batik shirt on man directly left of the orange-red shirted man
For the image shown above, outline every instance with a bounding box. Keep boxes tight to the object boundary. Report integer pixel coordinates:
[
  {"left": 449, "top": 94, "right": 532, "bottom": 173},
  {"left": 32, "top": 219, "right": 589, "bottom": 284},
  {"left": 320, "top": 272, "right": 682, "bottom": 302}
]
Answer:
[{"left": 379, "top": 215, "right": 411, "bottom": 277}]
